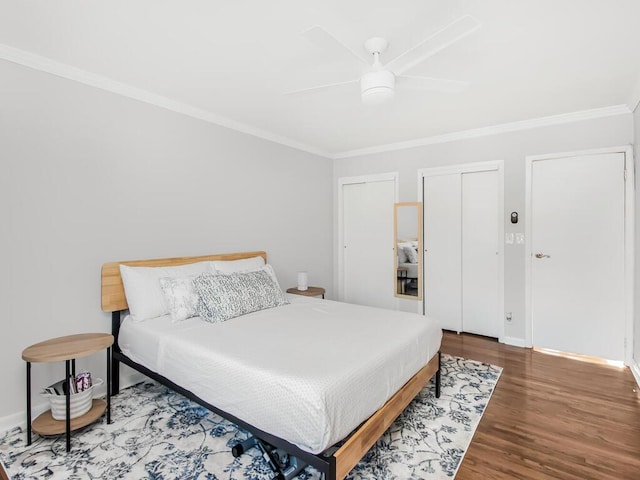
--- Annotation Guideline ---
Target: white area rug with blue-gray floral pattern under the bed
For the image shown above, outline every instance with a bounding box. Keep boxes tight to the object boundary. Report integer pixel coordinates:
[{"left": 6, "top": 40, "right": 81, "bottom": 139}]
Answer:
[{"left": 0, "top": 355, "right": 502, "bottom": 480}]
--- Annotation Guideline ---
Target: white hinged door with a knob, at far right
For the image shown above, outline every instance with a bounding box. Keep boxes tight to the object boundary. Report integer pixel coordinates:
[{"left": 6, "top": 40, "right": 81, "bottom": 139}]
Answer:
[{"left": 531, "top": 153, "right": 625, "bottom": 360}]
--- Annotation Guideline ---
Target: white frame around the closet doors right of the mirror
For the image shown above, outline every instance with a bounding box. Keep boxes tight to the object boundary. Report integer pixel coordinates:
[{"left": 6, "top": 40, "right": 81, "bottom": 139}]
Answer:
[{"left": 418, "top": 160, "right": 505, "bottom": 343}]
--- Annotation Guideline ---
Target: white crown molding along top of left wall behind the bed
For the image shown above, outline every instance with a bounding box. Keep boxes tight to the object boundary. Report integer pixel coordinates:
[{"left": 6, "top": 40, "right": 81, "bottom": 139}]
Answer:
[{"left": 0, "top": 43, "right": 333, "bottom": 159}]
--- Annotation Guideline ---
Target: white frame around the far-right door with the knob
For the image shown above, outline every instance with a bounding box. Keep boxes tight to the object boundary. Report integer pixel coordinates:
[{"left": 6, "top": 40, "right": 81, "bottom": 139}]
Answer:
[{"left": 524, "top": 145, "right": 635, "bottom": 365}]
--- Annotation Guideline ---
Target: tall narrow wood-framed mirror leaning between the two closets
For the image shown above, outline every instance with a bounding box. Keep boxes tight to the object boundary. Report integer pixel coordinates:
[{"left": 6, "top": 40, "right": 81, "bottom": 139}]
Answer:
[{"left": 394, "top": 202, "right": 422, "bottom": 300}]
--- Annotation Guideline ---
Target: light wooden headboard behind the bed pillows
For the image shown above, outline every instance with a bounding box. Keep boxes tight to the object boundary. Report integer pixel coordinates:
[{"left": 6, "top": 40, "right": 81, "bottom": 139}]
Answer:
[{"left": 101, "top": 252, "right": 267, "bottom": 312}]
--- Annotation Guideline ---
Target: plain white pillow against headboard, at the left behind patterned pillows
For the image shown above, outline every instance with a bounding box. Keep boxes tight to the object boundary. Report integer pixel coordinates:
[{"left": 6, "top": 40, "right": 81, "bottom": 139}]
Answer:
[{"left": 120, "top": 262, "right": 212, "bottom": 321}]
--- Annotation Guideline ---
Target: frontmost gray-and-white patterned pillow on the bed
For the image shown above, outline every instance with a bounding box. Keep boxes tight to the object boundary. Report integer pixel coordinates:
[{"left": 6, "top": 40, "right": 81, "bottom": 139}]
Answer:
[{"left": 193, "top": 270, "right": 289, "bottom": 323}]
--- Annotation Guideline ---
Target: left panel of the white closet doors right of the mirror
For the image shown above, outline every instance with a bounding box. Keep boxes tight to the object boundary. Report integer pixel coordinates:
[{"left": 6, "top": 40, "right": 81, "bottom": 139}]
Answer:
[{"left": 423, "top": 173, "right": 462, "bottom": 332}]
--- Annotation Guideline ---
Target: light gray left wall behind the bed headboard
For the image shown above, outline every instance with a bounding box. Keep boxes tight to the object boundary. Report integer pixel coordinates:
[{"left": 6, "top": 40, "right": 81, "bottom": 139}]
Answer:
[{"left": 0, "top": 61, "right": 333, "bottom": 426}]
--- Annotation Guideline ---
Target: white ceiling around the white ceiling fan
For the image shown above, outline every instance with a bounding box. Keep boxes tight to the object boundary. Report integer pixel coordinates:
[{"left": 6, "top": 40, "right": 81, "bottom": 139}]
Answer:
[{"left": 0, "top": 0, "right": 640, "bottom": 156}]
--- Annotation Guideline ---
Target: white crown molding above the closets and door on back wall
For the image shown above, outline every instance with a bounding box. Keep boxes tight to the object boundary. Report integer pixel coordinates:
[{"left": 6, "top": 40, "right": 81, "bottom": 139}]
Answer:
[{"left": 333, "top": 105, "right": 631, "bottom": 159}]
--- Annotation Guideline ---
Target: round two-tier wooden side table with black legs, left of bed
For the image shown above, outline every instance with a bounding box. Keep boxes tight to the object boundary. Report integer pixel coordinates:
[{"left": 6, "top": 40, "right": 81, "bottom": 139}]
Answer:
[{"left": 22, "top": 333, "right": 113, "bottom": 452}]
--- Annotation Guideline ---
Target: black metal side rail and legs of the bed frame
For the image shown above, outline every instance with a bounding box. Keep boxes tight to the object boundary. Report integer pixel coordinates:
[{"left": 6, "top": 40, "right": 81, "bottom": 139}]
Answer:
[{"left": 111, "top": 310, "right": 441, "bottom": 480}]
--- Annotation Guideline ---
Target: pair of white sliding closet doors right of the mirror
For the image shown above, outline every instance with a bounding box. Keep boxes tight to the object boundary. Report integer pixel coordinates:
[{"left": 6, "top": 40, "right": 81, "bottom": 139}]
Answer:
[{"left": 423, "top": 166, "right": 502, "bottom": 338}]
